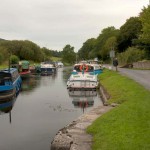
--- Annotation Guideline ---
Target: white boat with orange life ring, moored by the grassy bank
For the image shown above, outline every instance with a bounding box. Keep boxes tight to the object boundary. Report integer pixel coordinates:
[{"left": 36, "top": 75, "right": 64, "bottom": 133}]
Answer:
[{"left": 67, "top": 63, "right": 98, "bottom": 90}]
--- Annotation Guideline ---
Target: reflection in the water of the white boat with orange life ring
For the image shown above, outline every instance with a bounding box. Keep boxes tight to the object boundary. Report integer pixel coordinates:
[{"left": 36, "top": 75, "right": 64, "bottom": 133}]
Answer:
[{"left": 68, "top": 90, "right": 97, "bottom": 113}]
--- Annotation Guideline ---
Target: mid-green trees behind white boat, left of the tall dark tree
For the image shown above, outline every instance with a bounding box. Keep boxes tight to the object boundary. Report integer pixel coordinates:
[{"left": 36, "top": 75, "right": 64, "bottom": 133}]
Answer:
[{"left": 78, "top": 26, "right": 119, "bottom": 60}]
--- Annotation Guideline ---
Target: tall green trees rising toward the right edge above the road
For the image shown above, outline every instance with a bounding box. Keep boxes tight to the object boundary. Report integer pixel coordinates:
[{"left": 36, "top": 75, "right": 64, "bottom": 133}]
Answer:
[{"left": 78, "top": 6, "right": 150, "bottom": 63}]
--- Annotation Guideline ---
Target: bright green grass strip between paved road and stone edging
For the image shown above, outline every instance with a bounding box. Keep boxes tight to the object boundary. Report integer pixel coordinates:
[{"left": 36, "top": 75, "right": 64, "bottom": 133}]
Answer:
[{"left": 87, "top": 70, "right": 150, "bottom": 150}]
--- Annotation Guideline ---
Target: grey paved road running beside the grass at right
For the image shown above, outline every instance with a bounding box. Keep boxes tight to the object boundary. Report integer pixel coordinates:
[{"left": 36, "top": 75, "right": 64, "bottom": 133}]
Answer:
[{"left": 118, "top": 68, "right": 150, "bottom": 90}]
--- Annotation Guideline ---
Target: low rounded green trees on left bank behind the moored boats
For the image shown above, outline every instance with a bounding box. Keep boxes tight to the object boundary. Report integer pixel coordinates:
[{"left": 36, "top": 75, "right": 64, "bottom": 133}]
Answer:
[{"left": 0, "top": 39, "right": 62, "bottom": 63}]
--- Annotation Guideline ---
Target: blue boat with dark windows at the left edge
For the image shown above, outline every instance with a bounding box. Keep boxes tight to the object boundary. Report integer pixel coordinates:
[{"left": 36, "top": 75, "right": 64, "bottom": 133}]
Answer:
[{"left": 0, "top": 68, "right": 22, "bottom": 101}]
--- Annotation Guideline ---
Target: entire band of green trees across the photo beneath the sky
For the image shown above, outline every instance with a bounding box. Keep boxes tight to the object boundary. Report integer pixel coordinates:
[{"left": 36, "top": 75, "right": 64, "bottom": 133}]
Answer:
[{"left": 0, "top": 5, "right": 150, "bottom": 64}]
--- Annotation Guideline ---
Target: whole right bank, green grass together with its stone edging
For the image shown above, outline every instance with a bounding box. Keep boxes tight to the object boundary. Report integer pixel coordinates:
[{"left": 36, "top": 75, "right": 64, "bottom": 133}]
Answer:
[{"left": 52, "top": 70, "right": 150, "bottom": 150}]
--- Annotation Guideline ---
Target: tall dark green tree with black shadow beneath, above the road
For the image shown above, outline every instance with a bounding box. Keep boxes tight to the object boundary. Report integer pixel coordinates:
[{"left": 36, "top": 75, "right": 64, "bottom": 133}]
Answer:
[{"left": 117, "top": 17, "right": 142, "bottom": 52}]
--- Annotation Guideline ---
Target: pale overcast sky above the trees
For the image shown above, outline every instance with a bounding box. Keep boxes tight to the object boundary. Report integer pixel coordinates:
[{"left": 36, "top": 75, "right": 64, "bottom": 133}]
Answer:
[{"left": 0, "top": 0, "right": 149, "bottom": 52}]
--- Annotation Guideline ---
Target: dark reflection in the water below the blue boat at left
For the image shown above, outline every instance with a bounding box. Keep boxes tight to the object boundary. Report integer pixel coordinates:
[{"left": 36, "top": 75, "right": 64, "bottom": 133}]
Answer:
[{"left": 0, "top": 97, "right": 16, "bottom": 123}]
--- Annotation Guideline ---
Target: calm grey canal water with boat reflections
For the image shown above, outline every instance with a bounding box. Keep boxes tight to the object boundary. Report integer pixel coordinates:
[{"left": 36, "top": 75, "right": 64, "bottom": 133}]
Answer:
[{"left": 0, "top": 68, "right": 103, "bottom": 150}]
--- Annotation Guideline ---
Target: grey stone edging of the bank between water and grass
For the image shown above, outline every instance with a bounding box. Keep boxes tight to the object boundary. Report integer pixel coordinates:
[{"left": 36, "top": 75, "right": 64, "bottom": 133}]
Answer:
[{"left": 51, "top": 86, "right": 114, "bottom": 150}]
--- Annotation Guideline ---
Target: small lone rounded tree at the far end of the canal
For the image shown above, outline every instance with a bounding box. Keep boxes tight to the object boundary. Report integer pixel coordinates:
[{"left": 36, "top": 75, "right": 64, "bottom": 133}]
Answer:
[{"left": 62, "top": 44, "right": 76, "bottom": 64}]
